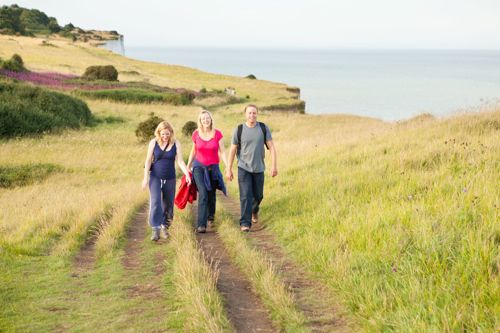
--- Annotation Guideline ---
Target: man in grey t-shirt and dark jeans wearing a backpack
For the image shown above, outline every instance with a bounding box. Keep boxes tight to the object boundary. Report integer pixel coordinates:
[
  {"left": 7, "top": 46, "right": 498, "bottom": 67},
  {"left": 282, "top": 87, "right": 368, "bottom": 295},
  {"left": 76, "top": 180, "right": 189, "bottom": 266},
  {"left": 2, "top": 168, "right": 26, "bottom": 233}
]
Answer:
[{"left": 226, "top": 104, "right": 278, "bottom": 232}]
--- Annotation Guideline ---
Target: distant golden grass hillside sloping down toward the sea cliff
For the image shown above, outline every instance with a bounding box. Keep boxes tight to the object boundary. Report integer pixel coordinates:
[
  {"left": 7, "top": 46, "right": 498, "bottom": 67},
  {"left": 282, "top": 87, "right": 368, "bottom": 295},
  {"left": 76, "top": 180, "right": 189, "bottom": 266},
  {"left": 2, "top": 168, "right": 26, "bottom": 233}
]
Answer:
[{"left": 0, "top": 35, "right": 300, "bottom": 108}]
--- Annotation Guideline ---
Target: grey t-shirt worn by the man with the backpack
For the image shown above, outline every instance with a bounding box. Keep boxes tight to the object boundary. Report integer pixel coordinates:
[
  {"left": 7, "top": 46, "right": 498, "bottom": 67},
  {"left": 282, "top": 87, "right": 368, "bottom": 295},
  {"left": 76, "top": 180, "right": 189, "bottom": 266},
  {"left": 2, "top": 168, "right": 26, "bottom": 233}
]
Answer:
[{"left": 231, "top": 123, "right": 273, "bottom": 173}]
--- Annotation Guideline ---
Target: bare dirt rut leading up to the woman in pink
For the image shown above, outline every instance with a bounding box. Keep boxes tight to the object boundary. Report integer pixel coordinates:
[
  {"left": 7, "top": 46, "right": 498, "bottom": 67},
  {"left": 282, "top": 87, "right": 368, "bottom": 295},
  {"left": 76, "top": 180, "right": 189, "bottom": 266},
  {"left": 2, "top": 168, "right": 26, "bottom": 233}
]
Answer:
[{"left": 193, "top": 205, "right": 277, "bottom": 333}]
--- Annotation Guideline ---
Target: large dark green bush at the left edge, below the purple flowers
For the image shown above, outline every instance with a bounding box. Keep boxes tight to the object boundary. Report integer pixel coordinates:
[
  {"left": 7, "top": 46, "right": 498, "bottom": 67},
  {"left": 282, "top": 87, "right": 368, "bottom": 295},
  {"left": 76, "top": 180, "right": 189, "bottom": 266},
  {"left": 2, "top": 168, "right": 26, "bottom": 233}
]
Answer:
[{"left": 0, "top": 82, "right": 93, "bottom": 138}]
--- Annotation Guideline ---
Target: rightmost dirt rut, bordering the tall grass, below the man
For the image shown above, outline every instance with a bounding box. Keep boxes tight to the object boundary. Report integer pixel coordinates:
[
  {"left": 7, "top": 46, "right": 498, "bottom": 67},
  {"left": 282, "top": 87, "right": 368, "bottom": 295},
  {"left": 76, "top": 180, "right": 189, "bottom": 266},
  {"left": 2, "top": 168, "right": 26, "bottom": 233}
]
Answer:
[{"left": 217, "top": 195, "right": 352, "bottom": 332}]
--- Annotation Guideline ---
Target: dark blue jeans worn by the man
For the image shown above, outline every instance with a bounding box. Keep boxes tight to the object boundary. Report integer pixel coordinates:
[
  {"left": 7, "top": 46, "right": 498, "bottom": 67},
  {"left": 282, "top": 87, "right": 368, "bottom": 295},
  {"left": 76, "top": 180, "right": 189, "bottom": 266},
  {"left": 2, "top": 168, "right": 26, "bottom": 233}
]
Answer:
[{"left": 238, "top": 168, "right": 264, "bottom": 227}]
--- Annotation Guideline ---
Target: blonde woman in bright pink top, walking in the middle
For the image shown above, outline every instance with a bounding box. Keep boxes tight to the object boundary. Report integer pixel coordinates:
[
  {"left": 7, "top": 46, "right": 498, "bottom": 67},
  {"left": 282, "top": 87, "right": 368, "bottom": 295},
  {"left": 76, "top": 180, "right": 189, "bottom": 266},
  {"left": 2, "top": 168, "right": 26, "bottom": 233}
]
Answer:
[{"left": 188, "top": 110, "right": 227, "bottom": 233}]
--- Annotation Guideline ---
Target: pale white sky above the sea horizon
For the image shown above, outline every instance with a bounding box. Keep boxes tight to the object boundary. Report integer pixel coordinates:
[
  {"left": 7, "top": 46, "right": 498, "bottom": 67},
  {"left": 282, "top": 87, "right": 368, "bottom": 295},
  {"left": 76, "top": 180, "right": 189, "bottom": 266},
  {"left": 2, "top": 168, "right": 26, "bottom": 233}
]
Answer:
[{"left": 0, "top": 0, "right": 500, "bottom": 50}]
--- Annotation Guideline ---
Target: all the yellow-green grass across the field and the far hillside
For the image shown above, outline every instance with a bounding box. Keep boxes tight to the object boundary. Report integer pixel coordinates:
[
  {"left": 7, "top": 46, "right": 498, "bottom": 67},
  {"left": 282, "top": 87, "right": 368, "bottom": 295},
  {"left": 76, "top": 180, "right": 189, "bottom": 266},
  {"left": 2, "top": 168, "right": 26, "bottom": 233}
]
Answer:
[{"left": 0, "top": 36, "right": 500, "bottom": 332}]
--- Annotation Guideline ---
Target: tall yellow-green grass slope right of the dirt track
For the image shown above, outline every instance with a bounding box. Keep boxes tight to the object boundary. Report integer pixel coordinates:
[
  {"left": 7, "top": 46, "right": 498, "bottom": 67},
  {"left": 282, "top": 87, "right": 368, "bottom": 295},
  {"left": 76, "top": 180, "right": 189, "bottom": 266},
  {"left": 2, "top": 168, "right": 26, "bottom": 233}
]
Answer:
[{"left": 262, "top": 110, "right": 500, "bottom": 332}]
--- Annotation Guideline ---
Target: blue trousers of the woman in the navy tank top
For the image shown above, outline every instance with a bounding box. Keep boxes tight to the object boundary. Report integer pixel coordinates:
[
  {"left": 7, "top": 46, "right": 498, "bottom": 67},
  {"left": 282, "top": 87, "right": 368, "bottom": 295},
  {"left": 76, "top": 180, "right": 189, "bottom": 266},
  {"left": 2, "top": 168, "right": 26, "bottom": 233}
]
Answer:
[{"left": 149, "top": 176, "right": 175, "bottom": 228}]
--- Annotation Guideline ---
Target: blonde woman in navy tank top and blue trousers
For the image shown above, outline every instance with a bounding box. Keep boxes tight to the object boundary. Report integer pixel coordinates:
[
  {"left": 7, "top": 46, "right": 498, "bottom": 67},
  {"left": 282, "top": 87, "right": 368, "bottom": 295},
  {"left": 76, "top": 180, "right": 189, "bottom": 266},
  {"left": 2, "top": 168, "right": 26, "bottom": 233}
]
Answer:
[{"left": 142, "top": 121, "right": 191, "bottom": 241}]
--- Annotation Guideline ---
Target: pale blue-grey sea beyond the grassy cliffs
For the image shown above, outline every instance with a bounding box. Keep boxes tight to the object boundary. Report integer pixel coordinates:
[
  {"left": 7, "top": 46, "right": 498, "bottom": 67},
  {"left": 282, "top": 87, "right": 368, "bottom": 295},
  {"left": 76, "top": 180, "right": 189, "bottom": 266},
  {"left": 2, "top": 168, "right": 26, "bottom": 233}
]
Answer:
[{"left": 104, "top": 41, "right": 500, "bottom": 121}]
